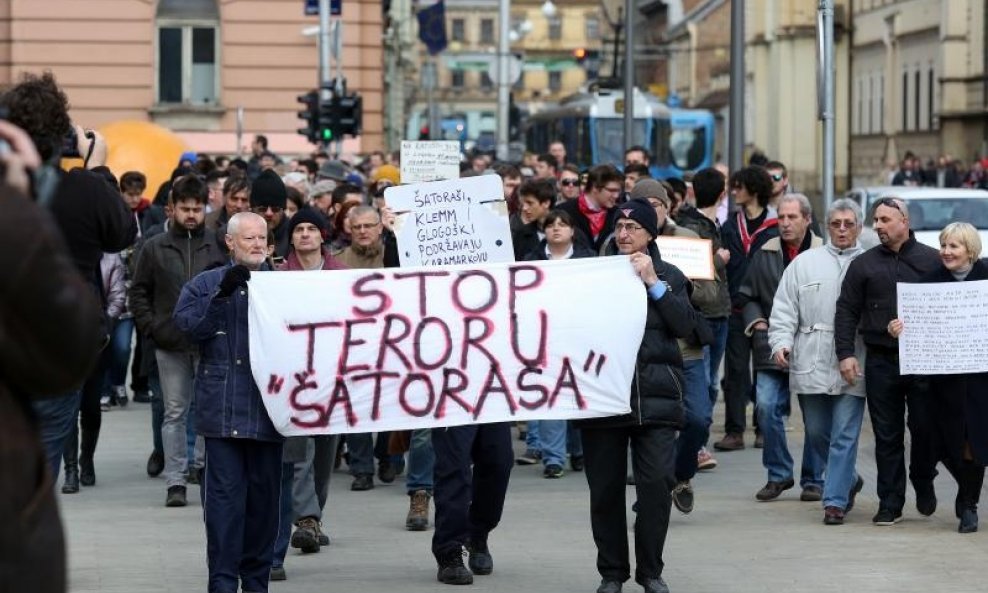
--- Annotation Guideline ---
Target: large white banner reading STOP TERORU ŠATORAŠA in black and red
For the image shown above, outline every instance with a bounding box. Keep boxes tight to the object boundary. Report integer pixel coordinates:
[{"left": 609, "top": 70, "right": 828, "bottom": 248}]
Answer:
[{"left": 248, "top": 257, "right": 646, "bottom": 436}]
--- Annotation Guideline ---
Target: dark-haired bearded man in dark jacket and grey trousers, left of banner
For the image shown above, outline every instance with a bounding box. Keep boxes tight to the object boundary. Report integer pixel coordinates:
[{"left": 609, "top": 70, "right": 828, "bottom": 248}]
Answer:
[{"left": 130, "top": 175, "right": 226, "bottom": 506}]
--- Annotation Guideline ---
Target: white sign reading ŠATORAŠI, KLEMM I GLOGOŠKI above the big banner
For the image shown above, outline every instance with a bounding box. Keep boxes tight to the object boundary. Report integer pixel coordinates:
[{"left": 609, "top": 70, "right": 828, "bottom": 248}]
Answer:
[{"left": 384, "top": 175, "right": 515, "bottom": 268}]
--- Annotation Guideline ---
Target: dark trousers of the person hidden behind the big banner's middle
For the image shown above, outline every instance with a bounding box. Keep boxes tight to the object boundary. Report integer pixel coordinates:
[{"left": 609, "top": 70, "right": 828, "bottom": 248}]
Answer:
[{"left": 432, "top": 422, "right": 514, "bottom": 559}]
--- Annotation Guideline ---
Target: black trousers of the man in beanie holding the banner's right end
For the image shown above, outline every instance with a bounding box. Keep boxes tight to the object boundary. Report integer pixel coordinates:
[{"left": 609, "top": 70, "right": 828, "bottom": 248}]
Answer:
[{"left": 582, "top": 426, "right": 676, "bottom": 582}]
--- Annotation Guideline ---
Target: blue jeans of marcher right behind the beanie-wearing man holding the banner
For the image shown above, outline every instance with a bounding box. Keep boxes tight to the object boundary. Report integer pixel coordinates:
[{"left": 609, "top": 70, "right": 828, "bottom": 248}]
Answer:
[{"left": 676, "top": 358, "right": 713, "bottom": 482}]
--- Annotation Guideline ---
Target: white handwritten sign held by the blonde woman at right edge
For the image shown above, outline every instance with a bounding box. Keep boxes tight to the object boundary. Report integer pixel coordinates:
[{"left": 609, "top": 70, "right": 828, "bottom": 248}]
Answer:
[{"left": 896, "top": 280, "right": 988, "bottom": 375}]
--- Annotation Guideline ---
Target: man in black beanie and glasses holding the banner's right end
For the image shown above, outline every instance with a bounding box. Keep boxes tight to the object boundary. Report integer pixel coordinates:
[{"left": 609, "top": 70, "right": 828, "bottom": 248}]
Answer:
[{"left": 580, "top": 199, "right": 696, "bottom": 593}]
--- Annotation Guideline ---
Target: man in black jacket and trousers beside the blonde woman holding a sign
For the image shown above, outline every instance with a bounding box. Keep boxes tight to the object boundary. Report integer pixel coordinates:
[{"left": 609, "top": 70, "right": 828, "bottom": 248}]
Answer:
[{"left": 834, "top": 198, "right": 940, "bottom": 525}]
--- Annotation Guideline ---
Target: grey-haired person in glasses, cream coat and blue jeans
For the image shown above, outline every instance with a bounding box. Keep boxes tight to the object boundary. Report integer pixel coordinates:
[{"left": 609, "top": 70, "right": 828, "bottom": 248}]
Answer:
[{"left": 768, "top": 199, "right": 865, "bottom": 525}]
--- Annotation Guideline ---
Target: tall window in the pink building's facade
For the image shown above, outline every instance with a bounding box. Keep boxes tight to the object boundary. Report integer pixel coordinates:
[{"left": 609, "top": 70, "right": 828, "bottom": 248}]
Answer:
[{"left": 156, "top": 0, "right": 219, "bottom": 105}]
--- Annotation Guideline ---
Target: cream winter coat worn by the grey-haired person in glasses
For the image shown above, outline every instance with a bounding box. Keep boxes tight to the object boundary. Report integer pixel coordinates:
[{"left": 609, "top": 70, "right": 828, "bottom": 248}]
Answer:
[{"left": 768, "top": 245, "right": 865, "bottom": 397}]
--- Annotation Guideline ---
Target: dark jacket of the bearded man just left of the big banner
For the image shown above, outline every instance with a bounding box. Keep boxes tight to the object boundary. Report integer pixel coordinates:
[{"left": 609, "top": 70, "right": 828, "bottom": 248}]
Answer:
[{"left": 128, "top": 224, "right": 227, "bottom": 352}]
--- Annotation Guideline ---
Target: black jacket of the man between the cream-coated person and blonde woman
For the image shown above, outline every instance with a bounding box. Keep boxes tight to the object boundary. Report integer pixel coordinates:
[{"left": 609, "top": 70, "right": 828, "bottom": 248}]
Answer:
[{"left": 834, "top": 231, "right": 941, "bottom": 360}]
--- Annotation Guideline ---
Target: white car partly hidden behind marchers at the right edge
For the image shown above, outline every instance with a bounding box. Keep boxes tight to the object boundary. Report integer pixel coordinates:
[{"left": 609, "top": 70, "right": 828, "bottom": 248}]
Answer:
[{"left": 846, "top": 185, "right": 988, "bottom": 249}]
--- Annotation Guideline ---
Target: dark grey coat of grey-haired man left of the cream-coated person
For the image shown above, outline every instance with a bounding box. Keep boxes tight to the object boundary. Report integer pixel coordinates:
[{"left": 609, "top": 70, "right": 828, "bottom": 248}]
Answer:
[{"left": 738, "top": 230, "right": 823, "bottom": 371}]
